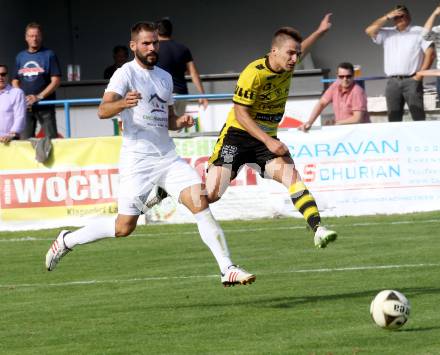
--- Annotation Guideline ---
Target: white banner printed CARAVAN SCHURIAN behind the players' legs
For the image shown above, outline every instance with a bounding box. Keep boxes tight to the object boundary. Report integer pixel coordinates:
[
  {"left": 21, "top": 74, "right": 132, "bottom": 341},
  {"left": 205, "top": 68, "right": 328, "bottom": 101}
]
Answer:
[{"left": 148, "top": 121, "right": 440, "bottom": 222}]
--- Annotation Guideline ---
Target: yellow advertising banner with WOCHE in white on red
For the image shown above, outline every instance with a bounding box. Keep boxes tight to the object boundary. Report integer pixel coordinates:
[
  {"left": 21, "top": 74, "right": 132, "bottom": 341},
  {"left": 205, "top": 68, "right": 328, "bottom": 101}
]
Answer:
[{"left": 0, "top": 137, "right": 121, "bottom": 227}]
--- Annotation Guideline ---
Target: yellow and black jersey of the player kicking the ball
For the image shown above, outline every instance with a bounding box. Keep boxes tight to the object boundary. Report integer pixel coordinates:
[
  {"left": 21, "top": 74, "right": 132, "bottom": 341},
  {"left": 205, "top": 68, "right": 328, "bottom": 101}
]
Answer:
[{"left": 226, "top": 57, "right": 293, "bottom": 136}]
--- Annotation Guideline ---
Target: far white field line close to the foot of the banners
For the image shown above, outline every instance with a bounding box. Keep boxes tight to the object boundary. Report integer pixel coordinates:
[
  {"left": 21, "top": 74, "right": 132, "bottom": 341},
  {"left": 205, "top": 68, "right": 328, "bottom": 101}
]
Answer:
[{"left": 0, "top": 219, "right": 440, "bottom": 243}]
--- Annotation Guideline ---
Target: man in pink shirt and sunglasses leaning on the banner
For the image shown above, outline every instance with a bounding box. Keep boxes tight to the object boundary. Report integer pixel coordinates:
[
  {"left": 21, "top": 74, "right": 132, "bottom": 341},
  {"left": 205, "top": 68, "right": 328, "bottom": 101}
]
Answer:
[{"left": 298, "top": 63, "right": 370, "bottom": 132}]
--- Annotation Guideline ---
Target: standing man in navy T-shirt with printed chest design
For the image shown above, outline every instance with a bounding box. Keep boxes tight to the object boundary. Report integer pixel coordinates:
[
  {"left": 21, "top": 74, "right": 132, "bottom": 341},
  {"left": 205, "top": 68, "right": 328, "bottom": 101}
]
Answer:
[{"left": 12, "top": 22, "right": 61, "bottom": 139}]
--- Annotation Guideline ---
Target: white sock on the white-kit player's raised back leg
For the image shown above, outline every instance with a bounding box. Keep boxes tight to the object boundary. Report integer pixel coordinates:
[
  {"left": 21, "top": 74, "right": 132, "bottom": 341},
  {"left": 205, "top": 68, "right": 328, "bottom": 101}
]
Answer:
[{"left": 64, "top": 219, "right": 115, "bottom": 249}]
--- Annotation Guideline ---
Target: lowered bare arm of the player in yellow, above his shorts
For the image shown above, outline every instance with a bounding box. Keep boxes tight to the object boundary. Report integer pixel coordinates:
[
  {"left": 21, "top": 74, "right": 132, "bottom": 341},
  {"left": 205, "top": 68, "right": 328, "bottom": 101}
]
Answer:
[{"left": 234, "top": 104, "right": 289, "bottom": 156}]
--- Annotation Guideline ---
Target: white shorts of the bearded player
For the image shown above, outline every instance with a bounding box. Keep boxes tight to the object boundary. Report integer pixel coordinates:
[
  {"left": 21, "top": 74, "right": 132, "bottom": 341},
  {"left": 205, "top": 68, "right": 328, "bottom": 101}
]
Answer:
[{"left": 118, "top": 157, "right": 202, "bottom": 216}]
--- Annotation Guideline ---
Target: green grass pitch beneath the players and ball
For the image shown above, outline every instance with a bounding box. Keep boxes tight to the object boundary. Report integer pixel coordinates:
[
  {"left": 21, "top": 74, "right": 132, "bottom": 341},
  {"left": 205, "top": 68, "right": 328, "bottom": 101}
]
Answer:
[{"left": 0, "top": 212, "right": 440, "bottom": 355}]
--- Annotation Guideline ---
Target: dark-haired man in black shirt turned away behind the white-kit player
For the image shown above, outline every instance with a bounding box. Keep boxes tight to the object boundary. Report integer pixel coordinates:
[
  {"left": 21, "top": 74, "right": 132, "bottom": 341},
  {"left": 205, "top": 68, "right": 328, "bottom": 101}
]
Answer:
[{"left": 156, "top": 18, "right": 208, "bottom": 116}]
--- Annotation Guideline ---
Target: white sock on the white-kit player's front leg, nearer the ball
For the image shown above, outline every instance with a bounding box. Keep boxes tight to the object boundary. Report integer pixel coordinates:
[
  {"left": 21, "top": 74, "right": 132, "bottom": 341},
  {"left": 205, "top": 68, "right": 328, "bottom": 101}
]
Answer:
[{"left": 194, "top": 208, "right": 233, "bottom": 272}]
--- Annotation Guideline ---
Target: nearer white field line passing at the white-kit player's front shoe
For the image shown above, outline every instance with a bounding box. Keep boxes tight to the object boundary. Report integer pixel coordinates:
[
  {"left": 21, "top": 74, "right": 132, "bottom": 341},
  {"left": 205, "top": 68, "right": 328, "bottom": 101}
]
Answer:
[{"left": 0, "top": 263, "right": 440, "bottom": 289}]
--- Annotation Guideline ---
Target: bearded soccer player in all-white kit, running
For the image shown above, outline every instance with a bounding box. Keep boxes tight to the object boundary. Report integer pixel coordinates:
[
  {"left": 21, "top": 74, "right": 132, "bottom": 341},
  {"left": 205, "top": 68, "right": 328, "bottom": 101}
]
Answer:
[{"left": 46, "top": 22, "right": 255, "bottom": 286}]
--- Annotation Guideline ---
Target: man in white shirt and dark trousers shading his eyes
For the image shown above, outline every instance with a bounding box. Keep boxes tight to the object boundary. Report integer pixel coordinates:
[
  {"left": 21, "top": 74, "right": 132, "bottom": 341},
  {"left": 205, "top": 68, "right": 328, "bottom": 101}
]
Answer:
[{"left": 365, "top": 5, "right": 434, "bottom": 122}]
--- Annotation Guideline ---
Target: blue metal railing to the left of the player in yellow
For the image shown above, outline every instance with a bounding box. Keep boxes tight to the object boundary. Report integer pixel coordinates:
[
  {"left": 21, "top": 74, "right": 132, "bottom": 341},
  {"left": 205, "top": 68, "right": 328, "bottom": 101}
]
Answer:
[{"left": 38, "top": 94, "right": 233, "bottom": 138}]
